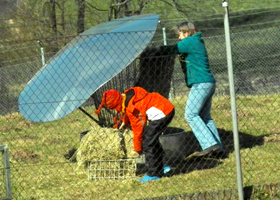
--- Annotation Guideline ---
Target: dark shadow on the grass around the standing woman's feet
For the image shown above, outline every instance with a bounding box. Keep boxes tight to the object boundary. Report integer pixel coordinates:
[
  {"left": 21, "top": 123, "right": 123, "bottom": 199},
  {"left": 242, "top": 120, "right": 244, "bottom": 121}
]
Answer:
[{"left": 160, "top": 129, "right": 264, "bottom": 175}]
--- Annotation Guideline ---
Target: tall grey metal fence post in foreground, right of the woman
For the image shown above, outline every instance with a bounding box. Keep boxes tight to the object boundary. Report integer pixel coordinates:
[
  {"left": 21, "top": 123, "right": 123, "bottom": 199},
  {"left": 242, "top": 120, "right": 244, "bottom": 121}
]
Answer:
[{"left": 222, "top": 1, "right": 244, "bottom": 200}]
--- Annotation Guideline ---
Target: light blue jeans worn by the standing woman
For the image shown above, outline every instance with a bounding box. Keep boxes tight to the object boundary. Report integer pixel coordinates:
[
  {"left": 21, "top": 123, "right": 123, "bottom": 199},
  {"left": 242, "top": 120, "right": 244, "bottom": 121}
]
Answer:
[{"left": 185, "top": 83, "right": 222, "bottom": 150}]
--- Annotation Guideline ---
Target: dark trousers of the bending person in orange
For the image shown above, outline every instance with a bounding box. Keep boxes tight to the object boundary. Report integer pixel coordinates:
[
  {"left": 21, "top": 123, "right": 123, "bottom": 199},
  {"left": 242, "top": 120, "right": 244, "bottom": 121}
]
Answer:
[{"left": 143, "top": 109, "right": 175, "bottom": 176}]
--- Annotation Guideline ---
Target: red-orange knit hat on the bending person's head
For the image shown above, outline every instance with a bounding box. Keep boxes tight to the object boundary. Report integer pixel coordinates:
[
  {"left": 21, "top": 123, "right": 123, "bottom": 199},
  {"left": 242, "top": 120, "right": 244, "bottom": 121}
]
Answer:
[{"left": 95, "top": 90, "right": 122, "bottom": 114}]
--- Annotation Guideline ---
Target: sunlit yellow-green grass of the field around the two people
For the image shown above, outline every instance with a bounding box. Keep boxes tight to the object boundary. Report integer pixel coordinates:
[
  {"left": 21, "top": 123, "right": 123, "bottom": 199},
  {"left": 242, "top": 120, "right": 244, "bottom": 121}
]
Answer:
[{"left": 0, "top": 95, "right": 280, "bottom": 200}]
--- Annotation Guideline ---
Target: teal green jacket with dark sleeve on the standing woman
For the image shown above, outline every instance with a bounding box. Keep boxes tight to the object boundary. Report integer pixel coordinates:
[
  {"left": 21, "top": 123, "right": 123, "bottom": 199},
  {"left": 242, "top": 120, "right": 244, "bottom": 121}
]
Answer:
[{"left": 163, "top": 32, "right": 215, "bottom": 87}]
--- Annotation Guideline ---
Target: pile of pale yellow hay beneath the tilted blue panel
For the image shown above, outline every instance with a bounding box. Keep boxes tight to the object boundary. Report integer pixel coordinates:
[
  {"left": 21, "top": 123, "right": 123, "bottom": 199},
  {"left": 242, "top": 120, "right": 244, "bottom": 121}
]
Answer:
[{"left": 76, "top": 126, "right": 136, "bottom": 166}]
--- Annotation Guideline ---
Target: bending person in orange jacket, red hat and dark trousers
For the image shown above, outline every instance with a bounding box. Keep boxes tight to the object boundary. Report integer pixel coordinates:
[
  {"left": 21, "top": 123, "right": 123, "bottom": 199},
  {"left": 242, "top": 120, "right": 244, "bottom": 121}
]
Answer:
[{"left": 95, "top": 87, "right": 175, "bottom": 182}]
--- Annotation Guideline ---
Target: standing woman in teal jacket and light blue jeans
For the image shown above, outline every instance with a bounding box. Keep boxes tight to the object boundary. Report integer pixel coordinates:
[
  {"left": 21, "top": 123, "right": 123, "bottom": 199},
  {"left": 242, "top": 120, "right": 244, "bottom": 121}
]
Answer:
[{"left": 161, "top": 22, "right": 223, "bottom": 157}]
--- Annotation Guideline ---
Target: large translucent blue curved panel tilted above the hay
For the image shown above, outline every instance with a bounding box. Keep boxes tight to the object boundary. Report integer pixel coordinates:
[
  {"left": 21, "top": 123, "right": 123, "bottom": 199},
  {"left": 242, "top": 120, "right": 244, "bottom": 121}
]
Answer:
[{"left": 18, "top": 14, "right": 159, "bottom": 122}]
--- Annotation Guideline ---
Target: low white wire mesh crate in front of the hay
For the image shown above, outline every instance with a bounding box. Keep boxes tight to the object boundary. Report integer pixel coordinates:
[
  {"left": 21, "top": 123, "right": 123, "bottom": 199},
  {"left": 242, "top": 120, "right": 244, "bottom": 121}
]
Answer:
[{"left": 88, "top": 159, "right": 136, "bottom": 180}]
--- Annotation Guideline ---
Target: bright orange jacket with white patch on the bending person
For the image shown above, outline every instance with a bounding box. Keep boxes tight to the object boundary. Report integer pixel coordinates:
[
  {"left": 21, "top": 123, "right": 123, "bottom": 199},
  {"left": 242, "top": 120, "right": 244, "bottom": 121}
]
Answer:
[{"left": 123, "top": 87, "right": 174, "bottom": 152}]
